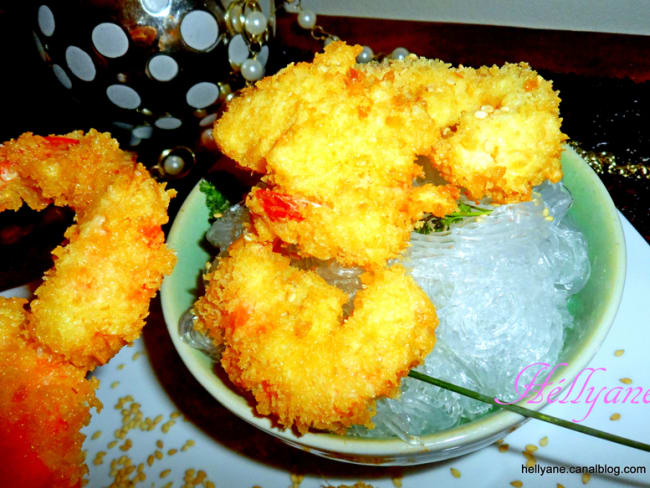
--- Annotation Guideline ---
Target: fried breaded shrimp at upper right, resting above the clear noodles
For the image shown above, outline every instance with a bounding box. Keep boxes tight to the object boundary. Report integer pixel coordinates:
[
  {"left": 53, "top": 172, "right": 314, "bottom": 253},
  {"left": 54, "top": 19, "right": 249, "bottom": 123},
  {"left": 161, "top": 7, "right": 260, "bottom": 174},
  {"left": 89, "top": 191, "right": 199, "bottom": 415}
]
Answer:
[{"left": 370, "top": 56, "right": 566, "bottom": 203}]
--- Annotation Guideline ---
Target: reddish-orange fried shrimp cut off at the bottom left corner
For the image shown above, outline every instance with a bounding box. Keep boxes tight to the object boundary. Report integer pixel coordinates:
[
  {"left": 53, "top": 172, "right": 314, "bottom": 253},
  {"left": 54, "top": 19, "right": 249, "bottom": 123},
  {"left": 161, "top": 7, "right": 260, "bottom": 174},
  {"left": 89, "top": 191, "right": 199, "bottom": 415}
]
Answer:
[{"left": 0, "top": 297, "right": 101, "bottom": 488}]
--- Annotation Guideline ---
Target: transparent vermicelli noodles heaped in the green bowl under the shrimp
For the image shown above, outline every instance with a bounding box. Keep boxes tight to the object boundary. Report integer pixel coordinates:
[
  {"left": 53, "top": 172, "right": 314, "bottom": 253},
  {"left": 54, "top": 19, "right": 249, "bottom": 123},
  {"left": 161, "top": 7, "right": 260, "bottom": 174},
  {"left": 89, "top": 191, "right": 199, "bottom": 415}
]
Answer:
[{"left": 185, "top": 183, "right": 590, "bottom": 443}]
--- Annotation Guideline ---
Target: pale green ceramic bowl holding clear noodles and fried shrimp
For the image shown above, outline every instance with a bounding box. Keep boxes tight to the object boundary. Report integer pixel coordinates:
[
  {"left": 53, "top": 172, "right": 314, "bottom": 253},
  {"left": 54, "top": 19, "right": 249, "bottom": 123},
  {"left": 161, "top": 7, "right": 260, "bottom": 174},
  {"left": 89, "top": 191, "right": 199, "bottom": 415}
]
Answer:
[{"left": 161, "top": 148, "right": 625, "bottom": 465}]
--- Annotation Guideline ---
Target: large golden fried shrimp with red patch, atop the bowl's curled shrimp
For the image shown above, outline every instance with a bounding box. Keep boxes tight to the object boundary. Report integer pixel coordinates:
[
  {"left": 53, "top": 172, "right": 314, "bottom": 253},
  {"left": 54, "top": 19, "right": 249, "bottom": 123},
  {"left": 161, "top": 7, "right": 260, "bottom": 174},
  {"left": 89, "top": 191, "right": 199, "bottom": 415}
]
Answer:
[{"left": 215, "top": 43, "right": 459, "bottom": 266}]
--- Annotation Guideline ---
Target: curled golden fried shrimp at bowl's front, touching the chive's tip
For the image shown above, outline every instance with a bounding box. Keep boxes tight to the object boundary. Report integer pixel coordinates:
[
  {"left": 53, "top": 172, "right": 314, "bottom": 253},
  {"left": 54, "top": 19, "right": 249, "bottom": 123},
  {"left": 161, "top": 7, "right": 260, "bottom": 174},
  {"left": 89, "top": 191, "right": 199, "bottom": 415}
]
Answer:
[{"left": 194, "top": 238, "right": 438, "bottom": 433}]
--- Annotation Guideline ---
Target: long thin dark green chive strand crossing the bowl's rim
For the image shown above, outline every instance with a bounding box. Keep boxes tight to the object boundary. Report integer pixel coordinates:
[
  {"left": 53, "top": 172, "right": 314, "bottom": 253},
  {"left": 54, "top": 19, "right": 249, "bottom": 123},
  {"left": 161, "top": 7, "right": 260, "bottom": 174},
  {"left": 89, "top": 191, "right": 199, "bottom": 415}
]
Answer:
[{"left": 409, "top": 371, "right": 650, "bottom": 452}]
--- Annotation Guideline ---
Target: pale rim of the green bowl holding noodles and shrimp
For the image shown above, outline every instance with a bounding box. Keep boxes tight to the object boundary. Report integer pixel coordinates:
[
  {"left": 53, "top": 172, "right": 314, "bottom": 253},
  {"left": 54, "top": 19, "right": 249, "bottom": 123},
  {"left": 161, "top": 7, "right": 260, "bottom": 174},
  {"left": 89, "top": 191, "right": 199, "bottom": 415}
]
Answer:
[{"left": 160, "top": 146, "right": 627, "bottom": 457}]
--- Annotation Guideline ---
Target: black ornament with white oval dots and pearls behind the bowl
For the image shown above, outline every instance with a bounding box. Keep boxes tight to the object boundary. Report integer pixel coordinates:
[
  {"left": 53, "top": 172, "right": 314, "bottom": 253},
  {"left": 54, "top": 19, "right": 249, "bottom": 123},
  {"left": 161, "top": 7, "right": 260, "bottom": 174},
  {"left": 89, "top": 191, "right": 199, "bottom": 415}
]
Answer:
[{"left": 32, "top": 0, "right": 275, "bottom": 178}]
